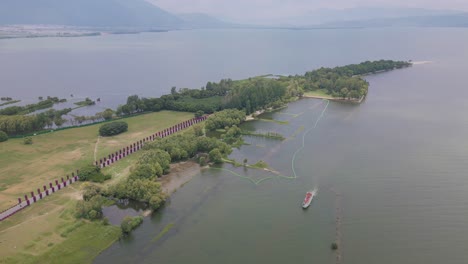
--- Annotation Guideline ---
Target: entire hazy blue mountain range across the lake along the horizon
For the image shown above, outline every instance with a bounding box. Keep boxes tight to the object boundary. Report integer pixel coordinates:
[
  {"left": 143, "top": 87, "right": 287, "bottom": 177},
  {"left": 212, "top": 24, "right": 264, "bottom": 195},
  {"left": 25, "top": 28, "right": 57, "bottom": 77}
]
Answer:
[{"left": 0, "top": 0, "right": 468, "bottom": 30}]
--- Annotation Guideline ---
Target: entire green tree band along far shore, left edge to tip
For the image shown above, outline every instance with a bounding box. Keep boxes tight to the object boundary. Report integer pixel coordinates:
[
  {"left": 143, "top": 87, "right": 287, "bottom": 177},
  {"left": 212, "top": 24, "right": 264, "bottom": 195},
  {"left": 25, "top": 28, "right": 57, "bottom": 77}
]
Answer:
[{"left": 0, "top": 60, "right": 411, "bottom": 135}]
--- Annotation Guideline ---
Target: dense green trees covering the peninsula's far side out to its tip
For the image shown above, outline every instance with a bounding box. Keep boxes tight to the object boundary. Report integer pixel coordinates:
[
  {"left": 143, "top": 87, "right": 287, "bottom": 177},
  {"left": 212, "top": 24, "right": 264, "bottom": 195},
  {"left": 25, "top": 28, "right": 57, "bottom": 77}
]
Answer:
[{"left": 117, "top": 60, "right": 411, "bottom": 115}]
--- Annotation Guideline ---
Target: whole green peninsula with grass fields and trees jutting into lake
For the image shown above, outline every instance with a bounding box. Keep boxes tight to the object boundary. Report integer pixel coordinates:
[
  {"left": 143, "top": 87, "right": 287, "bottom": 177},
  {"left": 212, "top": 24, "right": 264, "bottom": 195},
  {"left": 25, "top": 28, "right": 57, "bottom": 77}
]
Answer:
[{"left": 0, "top": 60, "right": 411, "bottom": 263}]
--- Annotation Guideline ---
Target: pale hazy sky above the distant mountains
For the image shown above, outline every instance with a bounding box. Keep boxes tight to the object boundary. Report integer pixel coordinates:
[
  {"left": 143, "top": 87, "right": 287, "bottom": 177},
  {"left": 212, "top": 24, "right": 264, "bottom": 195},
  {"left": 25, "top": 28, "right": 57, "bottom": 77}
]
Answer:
[{"left": 148, "top": 0, "right": 468, "bottom": 22}]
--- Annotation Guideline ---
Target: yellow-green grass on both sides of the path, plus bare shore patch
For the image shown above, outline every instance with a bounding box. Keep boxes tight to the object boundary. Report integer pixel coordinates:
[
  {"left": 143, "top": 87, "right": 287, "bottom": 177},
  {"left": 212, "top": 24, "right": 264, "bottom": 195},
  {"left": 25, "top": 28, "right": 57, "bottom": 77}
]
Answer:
[{"left": 0, "top": 111, "right": 193, "bottom": 263}]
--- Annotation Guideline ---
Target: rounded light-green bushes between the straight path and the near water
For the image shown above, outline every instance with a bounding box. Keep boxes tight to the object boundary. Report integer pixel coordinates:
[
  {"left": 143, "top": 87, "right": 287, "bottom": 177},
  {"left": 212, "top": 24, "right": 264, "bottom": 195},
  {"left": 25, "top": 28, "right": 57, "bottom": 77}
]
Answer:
[{"left": 106, "top": 125, "right": 232, "bottom": 209}]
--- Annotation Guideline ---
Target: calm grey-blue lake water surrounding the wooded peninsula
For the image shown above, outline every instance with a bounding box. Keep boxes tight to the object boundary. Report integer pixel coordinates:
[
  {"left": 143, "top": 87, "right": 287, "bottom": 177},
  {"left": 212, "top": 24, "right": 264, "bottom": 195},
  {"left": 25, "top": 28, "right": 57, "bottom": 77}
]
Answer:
[{"left": 0, "top": 28, "right": 468, "bottom": 264}]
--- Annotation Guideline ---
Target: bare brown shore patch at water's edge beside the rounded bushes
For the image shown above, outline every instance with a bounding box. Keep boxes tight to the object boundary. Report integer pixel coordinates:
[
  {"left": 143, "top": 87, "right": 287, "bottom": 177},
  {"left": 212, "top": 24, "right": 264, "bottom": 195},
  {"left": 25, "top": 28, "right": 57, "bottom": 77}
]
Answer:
[{"left": 159, "top": 161, "right": 201, "bottom": 195}]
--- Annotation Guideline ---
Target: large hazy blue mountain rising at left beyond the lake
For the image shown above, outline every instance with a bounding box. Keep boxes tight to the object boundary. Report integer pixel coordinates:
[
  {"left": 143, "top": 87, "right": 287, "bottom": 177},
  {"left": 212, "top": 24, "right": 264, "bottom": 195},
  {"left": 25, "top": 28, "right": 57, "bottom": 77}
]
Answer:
[{"left": 0, "top": 0, "right": 185, "bottom": 28}]
